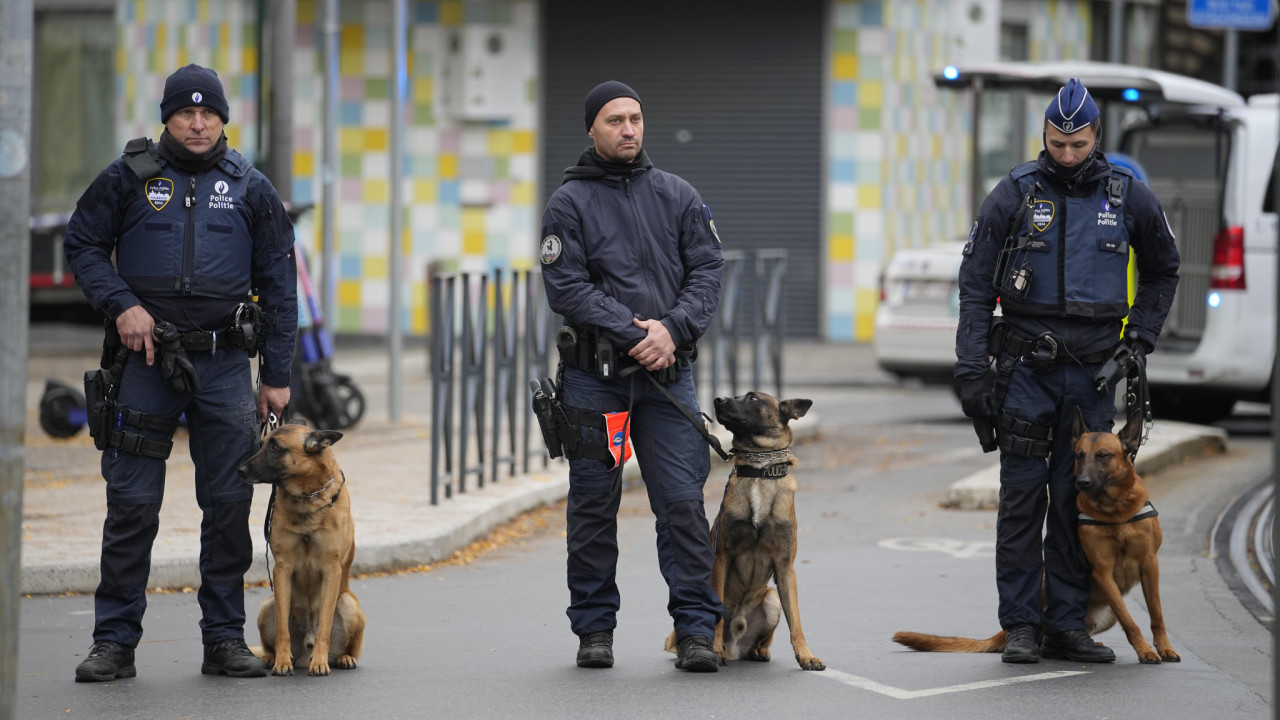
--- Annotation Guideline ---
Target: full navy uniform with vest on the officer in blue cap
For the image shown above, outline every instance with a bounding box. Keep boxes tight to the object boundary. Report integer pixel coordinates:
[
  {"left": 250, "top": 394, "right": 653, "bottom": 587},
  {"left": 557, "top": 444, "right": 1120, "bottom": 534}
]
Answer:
[{"left": 955, "top": 81, "right": 1179, "bottom": 645}]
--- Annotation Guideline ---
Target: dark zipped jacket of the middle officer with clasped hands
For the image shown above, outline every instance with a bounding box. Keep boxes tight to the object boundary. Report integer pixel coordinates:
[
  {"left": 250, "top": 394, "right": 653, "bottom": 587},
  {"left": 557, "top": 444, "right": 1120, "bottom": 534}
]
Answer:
[{"left": 539, "top": 149, "right": 724, "bottom": 348}]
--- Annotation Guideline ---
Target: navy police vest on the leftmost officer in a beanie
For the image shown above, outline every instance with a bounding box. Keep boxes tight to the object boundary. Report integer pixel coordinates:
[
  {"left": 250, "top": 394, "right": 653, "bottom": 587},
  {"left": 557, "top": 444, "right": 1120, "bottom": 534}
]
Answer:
[{"left": 116, "top": 143, "right": 253, "bottom": 301}]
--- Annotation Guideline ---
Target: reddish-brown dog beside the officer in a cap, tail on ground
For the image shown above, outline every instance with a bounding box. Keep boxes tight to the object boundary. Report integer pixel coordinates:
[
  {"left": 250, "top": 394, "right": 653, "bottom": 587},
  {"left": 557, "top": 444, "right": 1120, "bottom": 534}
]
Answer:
[{"left": 893, "top": 409, "right": 1181, "bottom": 664}]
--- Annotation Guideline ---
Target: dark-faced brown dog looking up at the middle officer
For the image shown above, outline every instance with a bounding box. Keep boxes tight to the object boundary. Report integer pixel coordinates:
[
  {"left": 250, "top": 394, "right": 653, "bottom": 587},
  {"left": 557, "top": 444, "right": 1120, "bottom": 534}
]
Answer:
[{"left": 667, "top": 392, "right": 827, "bottom": 670}]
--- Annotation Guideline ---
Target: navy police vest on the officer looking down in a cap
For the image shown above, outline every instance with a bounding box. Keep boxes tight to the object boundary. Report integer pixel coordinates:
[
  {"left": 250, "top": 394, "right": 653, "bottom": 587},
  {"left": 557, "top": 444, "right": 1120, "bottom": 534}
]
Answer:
[{"left": 1000, "top": 163, "right": 1133, "bottom": 320}]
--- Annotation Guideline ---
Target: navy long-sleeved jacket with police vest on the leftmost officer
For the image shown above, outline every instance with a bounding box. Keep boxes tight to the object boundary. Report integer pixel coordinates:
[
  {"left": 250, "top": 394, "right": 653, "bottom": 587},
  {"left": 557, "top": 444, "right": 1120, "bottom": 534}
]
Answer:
[{"left": 63, "top": 141, "right": 298, "bottom": 387}]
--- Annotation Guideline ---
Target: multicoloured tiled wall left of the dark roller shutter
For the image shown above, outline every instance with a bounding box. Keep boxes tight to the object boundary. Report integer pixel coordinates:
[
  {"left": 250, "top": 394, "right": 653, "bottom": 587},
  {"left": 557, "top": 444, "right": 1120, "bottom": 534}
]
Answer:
[{"left": 118, "top": 0, "right": 538, "bottom": 334}]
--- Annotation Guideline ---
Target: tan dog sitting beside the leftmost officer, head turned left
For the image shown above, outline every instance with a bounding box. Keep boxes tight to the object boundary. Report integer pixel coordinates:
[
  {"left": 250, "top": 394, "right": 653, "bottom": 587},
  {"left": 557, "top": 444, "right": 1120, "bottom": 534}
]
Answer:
[{"left": 239, "top": 425, "right": 365, "bottom": 675}]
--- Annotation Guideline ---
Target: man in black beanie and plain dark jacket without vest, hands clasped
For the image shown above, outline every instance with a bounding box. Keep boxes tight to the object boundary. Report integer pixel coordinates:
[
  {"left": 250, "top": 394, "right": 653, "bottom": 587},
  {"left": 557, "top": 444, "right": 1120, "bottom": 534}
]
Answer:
[{"left": 539, "top": 81, "right": 724, "bottom": 673}]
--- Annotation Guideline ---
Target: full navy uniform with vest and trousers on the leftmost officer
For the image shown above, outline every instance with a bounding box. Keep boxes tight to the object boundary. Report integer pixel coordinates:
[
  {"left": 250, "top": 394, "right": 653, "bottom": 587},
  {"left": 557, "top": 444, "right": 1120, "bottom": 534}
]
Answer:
[{"left": 64, "top": 70, "right": 297, "bottom": 648}]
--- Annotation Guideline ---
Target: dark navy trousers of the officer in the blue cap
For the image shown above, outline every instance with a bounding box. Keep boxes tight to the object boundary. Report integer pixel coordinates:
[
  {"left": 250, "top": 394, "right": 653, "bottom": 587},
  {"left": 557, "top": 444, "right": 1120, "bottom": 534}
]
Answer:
[{"left": 996, "top": 363, "right": 1115, "bottom": 633}]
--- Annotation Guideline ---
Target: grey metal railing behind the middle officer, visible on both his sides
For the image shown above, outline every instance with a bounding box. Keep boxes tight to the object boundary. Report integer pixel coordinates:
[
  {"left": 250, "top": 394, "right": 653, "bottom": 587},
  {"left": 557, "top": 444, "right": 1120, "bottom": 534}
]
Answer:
[{"left": 428, "top": 249, "right": 787, "bottom": 505}]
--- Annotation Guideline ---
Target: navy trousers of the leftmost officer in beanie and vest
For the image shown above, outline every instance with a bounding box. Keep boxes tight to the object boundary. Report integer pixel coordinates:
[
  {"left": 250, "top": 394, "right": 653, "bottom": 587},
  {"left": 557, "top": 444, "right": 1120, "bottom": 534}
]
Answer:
[{"left": 93, "top": 348, "right": 260, "bottom": 647}]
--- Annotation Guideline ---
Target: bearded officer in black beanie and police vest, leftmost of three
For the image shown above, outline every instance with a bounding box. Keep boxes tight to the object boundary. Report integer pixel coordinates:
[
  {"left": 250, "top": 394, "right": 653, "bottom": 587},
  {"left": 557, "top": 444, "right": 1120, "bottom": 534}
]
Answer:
[{"left": 64, "top": 65, "right": 297, "bottom": 683}]
